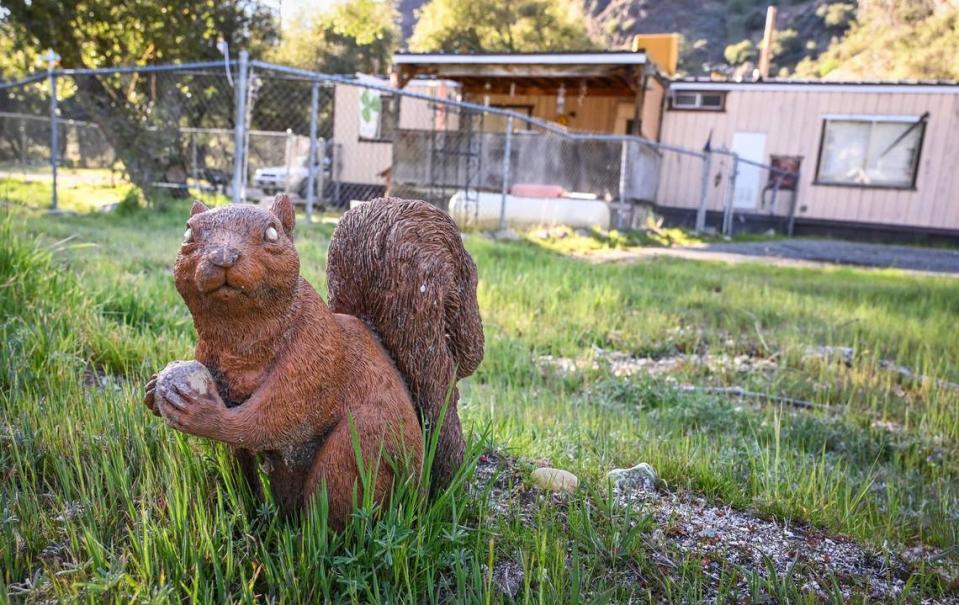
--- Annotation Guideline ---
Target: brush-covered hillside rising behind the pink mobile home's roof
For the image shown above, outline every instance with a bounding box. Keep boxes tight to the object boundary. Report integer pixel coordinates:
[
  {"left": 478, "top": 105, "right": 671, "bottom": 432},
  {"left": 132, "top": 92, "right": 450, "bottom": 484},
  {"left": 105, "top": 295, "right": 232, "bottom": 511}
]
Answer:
[{"left": 397, "top": 0, "right": 959, "bottom": 79}]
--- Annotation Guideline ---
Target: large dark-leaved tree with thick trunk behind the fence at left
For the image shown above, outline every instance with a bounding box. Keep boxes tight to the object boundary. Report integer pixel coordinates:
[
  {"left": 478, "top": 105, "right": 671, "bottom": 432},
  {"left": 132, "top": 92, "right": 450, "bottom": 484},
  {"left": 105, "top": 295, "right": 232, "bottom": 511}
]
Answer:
[{"left": 0, "top": 0, "right": 276, "bottom": 201}]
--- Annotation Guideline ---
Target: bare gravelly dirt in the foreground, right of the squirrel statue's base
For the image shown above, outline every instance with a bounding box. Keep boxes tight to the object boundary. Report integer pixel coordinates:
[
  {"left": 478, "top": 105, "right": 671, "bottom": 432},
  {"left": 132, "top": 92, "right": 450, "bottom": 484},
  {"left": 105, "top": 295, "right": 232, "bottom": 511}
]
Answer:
[{"left": 471, "top": 451, "right": 959, "bottom": 603}]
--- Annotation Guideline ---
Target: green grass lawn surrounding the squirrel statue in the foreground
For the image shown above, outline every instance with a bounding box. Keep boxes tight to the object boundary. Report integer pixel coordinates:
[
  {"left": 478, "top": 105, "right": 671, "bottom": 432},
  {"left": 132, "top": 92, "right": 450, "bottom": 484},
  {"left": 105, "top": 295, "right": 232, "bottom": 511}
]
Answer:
[{"left": 0, "top": 205, "right": 959, "bottom": 603}]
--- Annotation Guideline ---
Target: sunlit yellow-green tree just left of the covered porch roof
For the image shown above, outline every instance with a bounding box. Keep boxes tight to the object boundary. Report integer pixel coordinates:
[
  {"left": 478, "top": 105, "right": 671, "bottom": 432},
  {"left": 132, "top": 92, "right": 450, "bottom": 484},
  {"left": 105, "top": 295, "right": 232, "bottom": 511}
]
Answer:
[{"left": 269, "top": 0, "right": 400, "bottom": 74}]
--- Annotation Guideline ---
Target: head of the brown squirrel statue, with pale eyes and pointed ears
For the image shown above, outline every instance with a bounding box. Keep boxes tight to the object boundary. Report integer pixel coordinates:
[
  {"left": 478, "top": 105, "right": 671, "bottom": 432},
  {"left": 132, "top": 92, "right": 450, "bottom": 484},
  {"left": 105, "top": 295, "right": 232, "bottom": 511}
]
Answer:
[{"left": 173, "top": 194, "right": 300, "bottom": 320}]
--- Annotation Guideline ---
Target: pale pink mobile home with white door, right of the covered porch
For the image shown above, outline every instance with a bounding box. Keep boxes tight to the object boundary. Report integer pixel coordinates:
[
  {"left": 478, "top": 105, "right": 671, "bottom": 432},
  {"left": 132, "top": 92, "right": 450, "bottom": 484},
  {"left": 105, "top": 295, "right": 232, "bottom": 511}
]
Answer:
[{"left": 657, "top": 80, "right": 959, "bottom": 239}]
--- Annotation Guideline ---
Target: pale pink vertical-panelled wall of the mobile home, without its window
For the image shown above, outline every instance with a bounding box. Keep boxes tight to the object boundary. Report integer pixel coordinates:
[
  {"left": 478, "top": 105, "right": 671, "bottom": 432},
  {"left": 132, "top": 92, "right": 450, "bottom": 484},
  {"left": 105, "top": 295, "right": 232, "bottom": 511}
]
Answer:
[{"left": 658, "top": 85, "right": 959, "bottom": 229}]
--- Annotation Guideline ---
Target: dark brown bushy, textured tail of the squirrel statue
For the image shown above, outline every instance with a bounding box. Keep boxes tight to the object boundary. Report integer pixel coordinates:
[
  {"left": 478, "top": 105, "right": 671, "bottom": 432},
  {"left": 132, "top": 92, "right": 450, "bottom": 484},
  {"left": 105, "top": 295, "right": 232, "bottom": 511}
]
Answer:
[{"left": 327, "top": 198, "right": 483, "bottom": 493}]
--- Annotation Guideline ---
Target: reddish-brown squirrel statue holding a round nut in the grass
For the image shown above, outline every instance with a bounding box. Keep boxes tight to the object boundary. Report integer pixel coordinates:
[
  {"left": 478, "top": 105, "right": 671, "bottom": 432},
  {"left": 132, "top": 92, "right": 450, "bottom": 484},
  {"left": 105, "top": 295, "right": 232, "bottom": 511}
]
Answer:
[{"left": 144, "top": 194, "right": 483, "bottom": 528}]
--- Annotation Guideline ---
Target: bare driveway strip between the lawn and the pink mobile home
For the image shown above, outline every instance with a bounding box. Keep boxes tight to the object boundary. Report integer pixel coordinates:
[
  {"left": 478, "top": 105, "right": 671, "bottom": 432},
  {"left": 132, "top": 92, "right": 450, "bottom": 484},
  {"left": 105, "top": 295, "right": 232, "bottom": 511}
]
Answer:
[{"left": 590, "top": 239, "right": 959, "bottom": 277}]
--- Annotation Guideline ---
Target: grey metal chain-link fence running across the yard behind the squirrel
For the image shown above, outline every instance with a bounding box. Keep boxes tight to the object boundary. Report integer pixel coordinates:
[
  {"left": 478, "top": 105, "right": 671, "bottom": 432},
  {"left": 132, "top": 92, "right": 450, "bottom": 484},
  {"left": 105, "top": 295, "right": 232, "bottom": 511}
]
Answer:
[{"left": 0, "top": 53, "right": 798, "bottom": 233}]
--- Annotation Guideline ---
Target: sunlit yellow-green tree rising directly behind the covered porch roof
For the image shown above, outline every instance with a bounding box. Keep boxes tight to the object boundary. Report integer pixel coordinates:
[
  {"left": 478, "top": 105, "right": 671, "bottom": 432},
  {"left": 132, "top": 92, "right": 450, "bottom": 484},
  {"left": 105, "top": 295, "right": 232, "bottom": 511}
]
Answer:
[{"left": 410, "top": 0, "right": 597, "bottom": 53}]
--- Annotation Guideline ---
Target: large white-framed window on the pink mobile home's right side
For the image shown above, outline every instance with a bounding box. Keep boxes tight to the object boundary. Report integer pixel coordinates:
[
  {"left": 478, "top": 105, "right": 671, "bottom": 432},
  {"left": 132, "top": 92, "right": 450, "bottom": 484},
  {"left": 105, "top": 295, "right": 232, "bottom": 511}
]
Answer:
[{"left": 816, "top": 115, "right": 927, "bottom": 188}]
